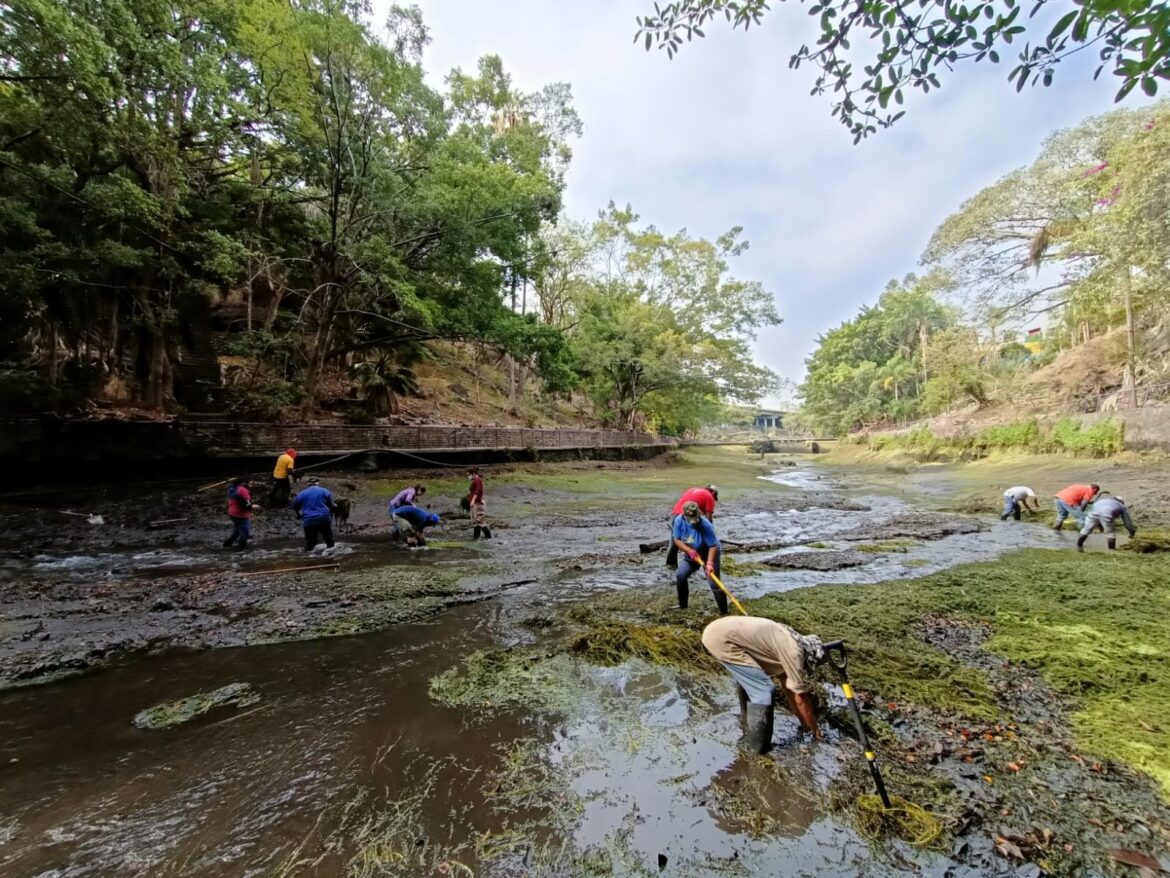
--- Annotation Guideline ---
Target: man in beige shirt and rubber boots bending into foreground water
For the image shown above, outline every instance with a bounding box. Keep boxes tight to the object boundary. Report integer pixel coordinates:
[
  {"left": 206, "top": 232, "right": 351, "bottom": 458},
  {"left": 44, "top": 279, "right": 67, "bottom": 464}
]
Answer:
[{"left": 703, "top": 616, "right": 825, "bottom": 753}]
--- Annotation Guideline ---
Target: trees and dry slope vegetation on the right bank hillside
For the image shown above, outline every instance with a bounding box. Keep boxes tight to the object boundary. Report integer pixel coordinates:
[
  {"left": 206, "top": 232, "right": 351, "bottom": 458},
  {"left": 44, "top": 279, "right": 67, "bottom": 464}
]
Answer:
[{"left": 799, "top": 101, "right": 1170, "bottom": 447}]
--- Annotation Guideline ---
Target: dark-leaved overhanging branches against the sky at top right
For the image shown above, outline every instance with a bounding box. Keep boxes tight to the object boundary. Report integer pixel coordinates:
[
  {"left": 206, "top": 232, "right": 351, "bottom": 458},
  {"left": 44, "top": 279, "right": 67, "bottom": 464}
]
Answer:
[{"left": 635, "top": 0, "right": 1170, "bottom": 140}]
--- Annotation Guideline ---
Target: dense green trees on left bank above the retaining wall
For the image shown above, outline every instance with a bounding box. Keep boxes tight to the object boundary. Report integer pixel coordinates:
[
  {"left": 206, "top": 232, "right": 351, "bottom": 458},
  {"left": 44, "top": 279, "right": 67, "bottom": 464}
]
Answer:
[{"left": 0, "top": 0, "right": 778, "bottom": 428}]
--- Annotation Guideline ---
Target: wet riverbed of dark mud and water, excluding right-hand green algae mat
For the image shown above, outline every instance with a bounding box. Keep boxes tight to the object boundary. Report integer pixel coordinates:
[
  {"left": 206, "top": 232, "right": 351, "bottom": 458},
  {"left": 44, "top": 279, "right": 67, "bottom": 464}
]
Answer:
[{"left": 0, "top": 450, "right": 1161, "bottom": 878}]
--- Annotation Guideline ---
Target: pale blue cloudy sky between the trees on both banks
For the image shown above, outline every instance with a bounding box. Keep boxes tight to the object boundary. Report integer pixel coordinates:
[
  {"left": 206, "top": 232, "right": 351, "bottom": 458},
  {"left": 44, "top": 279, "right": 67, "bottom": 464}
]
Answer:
[{"left": 374, "top": 0, "right": 1141, "bottom": 404}]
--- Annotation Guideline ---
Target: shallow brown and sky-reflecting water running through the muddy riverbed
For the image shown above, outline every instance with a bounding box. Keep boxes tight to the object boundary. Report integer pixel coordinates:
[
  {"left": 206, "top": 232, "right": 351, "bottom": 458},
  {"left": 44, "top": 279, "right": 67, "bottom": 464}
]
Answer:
[{"left": 0, "top": 468, "right": 1061, "bottom": 878}]
